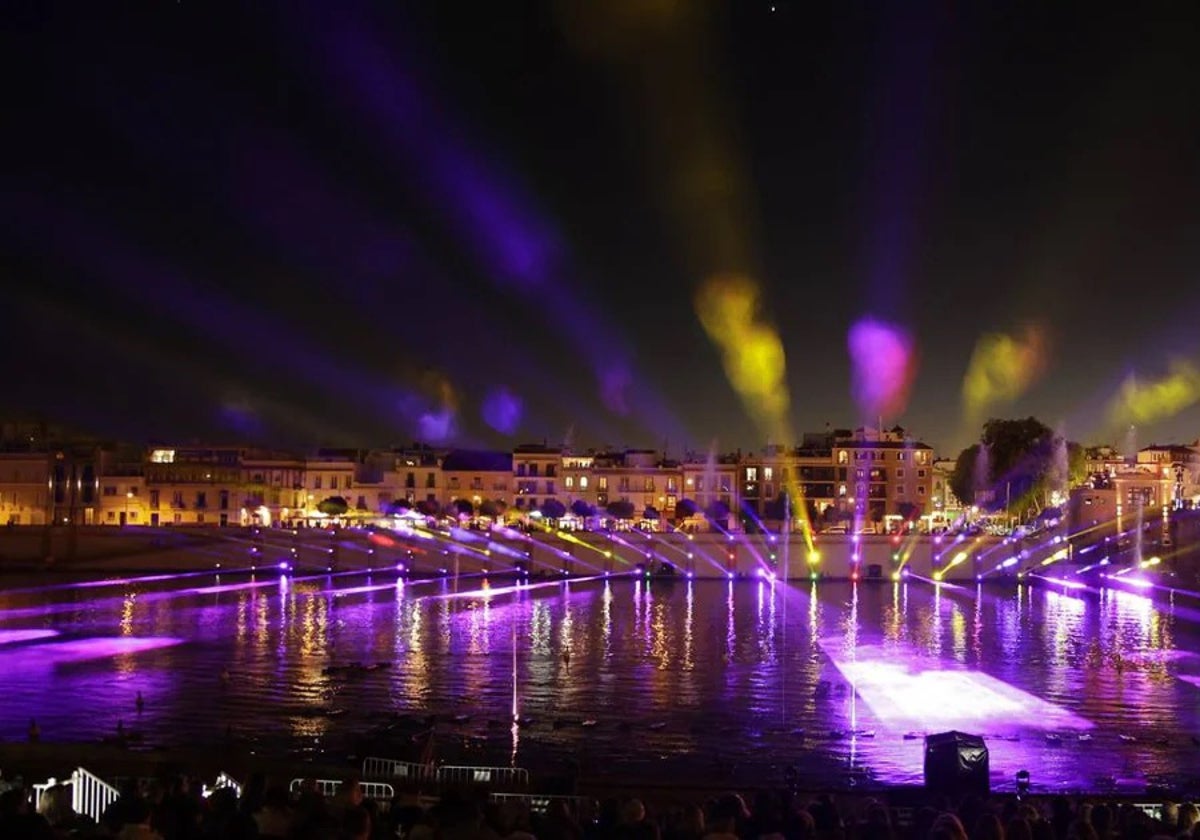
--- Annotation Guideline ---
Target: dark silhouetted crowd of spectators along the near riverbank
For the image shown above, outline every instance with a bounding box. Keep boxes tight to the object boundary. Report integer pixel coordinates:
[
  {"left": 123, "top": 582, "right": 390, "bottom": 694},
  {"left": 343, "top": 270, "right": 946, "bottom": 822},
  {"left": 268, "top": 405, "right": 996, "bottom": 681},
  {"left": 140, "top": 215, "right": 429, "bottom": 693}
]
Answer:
[{"left": 0, "top": 776, "right": 1200, "bottom": 840}]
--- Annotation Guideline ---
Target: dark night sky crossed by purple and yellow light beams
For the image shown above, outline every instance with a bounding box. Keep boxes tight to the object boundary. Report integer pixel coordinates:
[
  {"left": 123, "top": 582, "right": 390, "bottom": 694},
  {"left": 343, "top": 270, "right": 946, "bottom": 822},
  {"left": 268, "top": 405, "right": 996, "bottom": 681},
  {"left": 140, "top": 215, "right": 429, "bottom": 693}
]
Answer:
[{"left": 7, "top": 0, "right": 1200, "bottom": 455}]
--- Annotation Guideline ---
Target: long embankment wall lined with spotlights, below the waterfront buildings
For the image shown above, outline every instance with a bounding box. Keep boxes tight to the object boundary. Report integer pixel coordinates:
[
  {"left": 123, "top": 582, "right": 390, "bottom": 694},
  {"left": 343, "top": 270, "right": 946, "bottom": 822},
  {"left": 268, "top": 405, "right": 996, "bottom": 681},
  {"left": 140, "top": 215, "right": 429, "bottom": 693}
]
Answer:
[{"left": 0, "top": 527, "right": 1032, "bottom": 581}]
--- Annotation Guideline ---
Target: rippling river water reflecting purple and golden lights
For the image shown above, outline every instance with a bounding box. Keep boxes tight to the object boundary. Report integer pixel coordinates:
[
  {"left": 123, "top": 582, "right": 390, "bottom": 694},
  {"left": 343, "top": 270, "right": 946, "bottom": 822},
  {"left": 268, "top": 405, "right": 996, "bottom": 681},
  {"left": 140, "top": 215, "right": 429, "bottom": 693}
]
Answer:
[{"left": 0, "top": 574, "right": 1200, "bottom": 791}]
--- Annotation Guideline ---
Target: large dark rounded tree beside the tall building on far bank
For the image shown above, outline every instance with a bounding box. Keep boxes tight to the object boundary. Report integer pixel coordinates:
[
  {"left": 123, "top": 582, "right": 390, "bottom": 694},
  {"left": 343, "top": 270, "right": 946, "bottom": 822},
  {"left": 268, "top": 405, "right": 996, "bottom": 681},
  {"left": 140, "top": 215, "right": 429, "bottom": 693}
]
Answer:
[{"left": 949, "top": 418, "right": 1087, "bottom": 518}]
